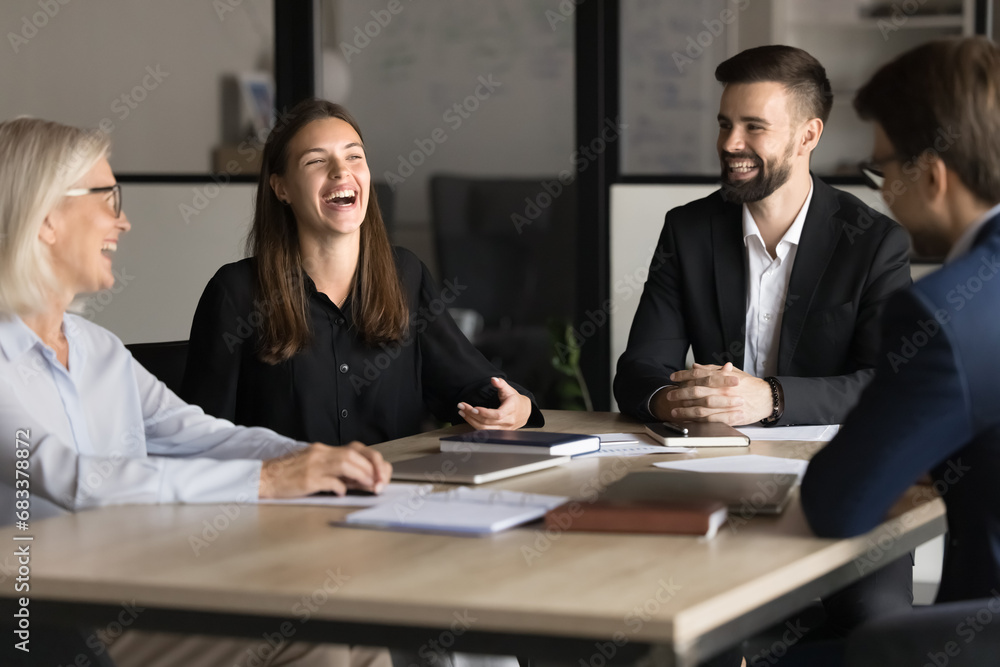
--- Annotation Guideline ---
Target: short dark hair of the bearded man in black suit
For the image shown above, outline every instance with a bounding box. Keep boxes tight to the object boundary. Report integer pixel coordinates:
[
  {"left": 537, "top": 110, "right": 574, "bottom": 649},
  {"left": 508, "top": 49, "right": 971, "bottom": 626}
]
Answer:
[{"left": 715, "top": 44, "right": 833, "bottom": 125}]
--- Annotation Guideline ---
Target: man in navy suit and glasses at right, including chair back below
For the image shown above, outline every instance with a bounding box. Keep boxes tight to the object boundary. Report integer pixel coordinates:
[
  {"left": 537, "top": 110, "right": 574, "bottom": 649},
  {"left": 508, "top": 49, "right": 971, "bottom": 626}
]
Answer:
[{"left": 802, "top": 37, "right": 1000, "bottom": 667}]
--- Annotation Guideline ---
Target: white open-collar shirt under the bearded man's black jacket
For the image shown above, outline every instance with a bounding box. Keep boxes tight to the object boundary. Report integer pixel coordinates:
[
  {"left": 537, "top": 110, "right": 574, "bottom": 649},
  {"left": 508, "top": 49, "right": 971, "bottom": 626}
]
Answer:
[{"left": 743, "top": 181, "right": 813, "bottom": 378}]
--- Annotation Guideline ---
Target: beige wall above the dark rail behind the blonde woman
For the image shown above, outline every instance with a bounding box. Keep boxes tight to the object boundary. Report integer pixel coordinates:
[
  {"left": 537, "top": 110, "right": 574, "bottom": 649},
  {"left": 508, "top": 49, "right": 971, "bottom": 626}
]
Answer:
[{"left": 0, "top": 0, "right": 274, "bottom": 173}]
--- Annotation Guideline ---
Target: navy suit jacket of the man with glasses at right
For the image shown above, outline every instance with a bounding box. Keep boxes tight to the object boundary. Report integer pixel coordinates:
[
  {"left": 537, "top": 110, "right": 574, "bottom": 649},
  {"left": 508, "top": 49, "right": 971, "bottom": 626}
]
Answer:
[{"left": 802, "top": 216, "right": 1000, "bottom": 602}]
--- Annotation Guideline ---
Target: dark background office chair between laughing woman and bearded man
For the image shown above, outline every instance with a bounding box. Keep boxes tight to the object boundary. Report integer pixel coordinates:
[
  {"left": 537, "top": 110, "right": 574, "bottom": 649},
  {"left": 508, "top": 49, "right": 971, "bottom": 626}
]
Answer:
[{"left": 430, "top": 175, "right": 576, "bottom": 406}]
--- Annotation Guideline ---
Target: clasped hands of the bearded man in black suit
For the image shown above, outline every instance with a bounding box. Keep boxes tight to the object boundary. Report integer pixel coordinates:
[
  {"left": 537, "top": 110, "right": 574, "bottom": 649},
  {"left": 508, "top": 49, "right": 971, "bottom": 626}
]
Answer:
[{"left": 650, "top": 363, "right": 774, "bottom": 426}]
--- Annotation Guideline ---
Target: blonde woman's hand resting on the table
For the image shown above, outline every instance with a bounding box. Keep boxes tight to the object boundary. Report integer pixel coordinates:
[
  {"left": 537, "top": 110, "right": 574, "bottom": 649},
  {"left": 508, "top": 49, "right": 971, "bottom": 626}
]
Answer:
[{"left": 260, "top": 441, "right": 392, "bottom": 498}]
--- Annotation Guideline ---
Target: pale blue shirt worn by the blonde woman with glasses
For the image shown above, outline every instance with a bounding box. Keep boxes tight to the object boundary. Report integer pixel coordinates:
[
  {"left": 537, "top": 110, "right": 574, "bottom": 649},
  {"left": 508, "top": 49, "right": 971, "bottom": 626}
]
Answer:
[{"left": 0, "top": 314, "right": 305, "bottom": 525}]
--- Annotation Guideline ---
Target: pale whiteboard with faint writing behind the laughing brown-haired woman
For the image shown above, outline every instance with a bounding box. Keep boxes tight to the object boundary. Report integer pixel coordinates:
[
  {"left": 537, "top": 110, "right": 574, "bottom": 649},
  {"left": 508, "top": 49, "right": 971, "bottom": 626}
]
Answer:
[{"left": 324, "top": 0, "right": 575, "bottom": 224}]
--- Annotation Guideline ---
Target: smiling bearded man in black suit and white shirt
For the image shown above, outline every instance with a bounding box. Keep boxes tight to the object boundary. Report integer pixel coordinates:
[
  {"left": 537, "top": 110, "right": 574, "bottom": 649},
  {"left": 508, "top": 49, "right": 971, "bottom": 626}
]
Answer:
[{"left": 615, "top": 46, "right": 912, "bottom": 664}]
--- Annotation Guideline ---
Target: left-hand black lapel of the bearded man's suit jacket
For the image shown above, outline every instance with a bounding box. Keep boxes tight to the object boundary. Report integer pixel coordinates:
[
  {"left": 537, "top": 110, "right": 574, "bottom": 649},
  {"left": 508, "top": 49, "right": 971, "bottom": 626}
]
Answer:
[{"left": 712, "top": 205, "right": 747, "bottom": 369}]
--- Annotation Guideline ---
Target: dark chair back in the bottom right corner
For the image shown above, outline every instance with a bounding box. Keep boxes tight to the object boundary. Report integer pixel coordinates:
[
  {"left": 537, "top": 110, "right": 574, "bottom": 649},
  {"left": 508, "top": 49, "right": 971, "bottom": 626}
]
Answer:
[{"left": 845, "top": 594, "right": 1000, "bottom": 667}]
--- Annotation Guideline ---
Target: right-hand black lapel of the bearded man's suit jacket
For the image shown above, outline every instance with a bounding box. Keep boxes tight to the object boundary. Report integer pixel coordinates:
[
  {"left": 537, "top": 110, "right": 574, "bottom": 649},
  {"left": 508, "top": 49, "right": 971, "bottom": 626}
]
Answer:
[{"left": 778, "top": 178, "right": 843, "bottom": 374}]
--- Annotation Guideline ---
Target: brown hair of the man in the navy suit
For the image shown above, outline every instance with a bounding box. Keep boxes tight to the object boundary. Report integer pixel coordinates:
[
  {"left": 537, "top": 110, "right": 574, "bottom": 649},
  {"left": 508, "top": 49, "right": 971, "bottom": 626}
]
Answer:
[{"left": 854, "top": 37, "right": 1000, "bottom": 204}]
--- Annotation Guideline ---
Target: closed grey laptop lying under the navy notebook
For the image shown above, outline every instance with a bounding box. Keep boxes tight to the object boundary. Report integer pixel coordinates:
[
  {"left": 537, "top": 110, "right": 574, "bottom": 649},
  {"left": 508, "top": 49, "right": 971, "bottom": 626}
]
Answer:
[{"left": 392, "top": 452, "right": 572, "bottom": 484}]
